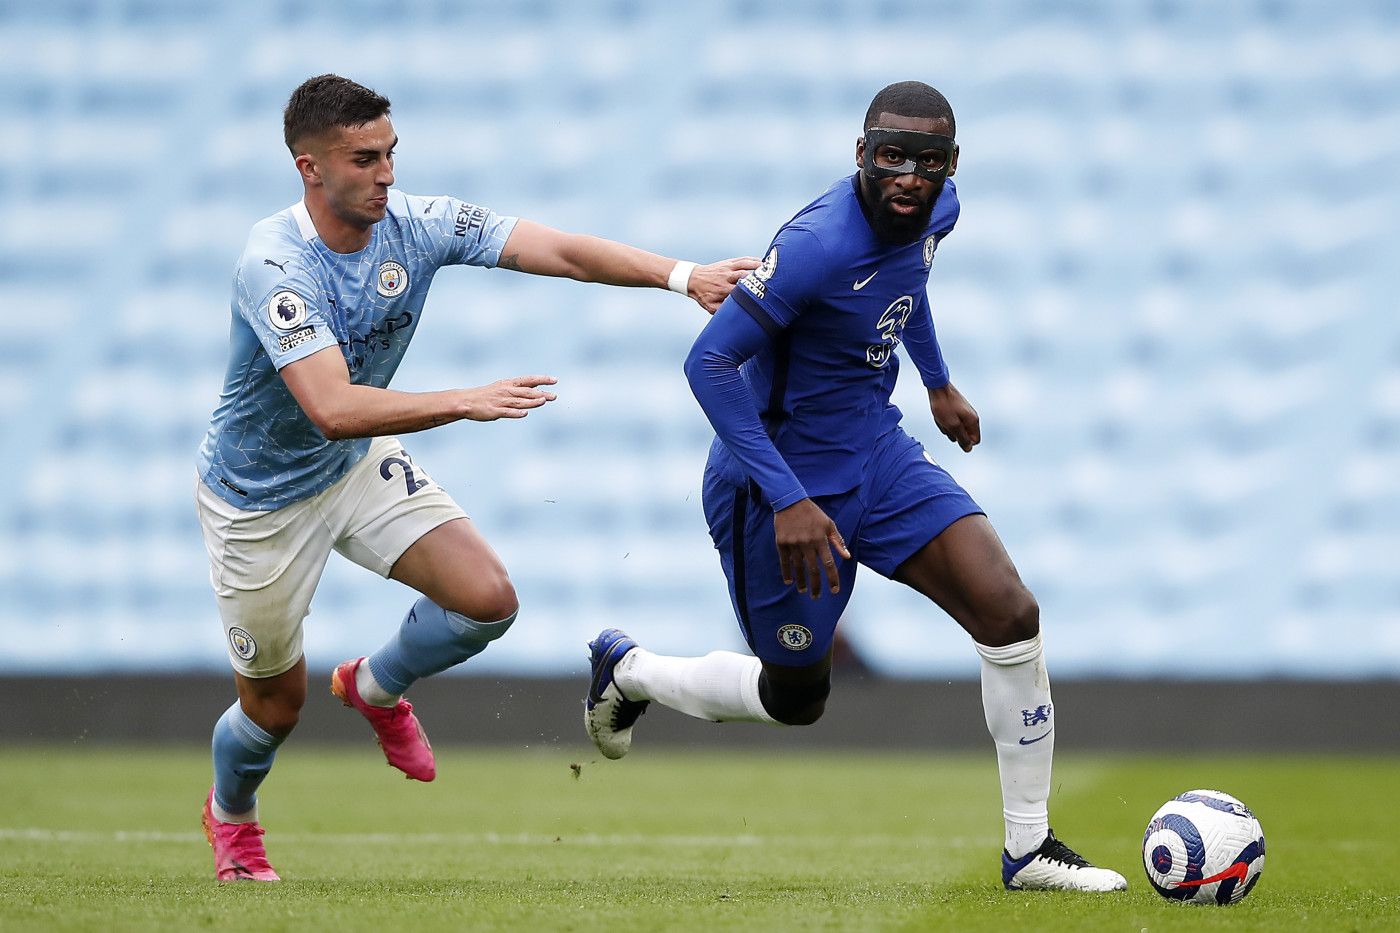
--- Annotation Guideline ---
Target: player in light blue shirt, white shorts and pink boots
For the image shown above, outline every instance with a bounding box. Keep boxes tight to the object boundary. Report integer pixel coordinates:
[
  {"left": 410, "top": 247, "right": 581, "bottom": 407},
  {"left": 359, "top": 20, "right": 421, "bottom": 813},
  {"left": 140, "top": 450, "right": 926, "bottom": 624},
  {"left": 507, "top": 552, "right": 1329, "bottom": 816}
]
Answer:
[{"left": 196, "top": 74, "right": 757, "bottom": 881}]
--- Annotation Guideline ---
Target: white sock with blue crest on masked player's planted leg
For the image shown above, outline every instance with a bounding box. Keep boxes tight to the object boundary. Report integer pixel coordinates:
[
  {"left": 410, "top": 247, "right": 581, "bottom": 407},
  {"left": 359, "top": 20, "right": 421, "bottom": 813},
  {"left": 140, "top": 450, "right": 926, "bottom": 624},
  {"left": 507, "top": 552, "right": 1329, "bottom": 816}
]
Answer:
[{"left": 977, "top": 635, "right": 1054, "bottom": 859}]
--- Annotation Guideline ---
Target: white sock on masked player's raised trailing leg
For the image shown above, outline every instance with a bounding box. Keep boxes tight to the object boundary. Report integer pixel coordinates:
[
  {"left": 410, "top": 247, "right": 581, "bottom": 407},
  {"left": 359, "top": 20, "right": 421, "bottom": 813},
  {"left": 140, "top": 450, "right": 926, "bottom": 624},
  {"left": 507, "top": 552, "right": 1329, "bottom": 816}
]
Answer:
[{"left": 613, "top": 649, "right": 777, "bottom": 724}]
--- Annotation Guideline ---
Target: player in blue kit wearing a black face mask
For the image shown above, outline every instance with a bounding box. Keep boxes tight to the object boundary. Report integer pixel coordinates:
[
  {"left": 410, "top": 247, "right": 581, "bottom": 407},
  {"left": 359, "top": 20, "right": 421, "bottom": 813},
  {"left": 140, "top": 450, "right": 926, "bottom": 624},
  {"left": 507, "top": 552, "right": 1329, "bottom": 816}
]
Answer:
[{"left": 584, "top": 81, "right": 1127, "bottom": 891}]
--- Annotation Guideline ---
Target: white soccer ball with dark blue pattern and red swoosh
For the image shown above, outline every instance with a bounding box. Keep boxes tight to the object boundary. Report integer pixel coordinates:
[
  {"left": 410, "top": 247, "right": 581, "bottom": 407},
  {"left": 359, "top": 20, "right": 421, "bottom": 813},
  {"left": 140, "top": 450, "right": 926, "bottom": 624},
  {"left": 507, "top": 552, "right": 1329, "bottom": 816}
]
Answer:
[{"left": 1142, "top": 790, "right": 1264, "bottom": 904}]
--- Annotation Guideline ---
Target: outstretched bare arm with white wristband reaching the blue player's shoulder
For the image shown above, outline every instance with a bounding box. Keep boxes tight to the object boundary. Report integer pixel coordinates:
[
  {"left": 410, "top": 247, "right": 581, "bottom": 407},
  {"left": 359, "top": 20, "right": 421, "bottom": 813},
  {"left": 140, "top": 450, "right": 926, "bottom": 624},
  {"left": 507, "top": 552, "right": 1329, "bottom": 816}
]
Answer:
[{"left": 497, "top": 220, "right": 759, "bottom": 314}]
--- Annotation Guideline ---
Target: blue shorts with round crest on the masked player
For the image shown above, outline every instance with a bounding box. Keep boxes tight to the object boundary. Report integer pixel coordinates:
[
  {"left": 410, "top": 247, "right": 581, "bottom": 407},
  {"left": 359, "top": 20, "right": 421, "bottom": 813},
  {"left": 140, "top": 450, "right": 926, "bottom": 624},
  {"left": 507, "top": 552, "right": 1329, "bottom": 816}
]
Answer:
[{"left": 704, "top": 426, "right": 981, "bottom": 667}]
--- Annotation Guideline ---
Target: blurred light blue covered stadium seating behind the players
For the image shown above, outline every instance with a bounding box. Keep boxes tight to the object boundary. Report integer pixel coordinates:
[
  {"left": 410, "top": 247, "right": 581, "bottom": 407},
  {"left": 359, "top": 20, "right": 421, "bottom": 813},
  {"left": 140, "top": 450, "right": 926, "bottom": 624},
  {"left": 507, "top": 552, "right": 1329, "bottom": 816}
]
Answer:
[{"left": 0, "top": 0, "right": 1400, "bottom": 678}]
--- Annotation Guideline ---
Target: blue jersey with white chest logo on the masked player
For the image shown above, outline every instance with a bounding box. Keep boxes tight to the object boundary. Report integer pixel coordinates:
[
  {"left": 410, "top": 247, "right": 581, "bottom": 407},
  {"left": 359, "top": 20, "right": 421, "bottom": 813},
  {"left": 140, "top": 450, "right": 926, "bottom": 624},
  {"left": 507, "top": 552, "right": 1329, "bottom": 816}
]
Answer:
[{"left": 707, "top": 175, "right": 958, "bottom": 509}]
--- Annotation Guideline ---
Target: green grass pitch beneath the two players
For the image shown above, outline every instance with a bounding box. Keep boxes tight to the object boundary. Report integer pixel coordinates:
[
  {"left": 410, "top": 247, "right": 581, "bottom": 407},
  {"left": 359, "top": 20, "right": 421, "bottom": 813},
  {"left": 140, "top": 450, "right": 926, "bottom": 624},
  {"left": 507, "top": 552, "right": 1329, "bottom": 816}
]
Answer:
[{"left": 0, "top": 740, "right": 1400, "bottom": 933}]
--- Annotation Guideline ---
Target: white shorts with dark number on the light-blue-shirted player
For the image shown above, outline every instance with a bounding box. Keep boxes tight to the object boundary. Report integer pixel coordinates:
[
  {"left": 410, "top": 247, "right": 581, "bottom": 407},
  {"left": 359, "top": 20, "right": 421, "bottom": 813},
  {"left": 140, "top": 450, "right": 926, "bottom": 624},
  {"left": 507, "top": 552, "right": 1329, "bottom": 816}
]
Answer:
[{"left": 195, "top": 437, "right": 466, "bottom": 678}]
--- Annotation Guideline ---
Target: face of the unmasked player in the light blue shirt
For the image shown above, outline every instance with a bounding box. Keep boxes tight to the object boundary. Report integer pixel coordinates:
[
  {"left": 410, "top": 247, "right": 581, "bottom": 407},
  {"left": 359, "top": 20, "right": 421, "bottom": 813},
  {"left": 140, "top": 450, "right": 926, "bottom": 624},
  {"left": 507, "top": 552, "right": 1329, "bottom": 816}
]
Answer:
[{"left": 311, "top": 116, "right": 399, "bottom": 230}]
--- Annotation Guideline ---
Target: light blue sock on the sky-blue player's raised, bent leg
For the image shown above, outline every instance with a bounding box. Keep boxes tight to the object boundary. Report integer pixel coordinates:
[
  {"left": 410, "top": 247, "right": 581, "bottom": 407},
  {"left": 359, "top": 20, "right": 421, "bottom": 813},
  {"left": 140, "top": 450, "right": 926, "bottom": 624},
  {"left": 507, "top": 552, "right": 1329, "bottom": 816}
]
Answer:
[{"left": 370, "top": 597, "right": 519, "bottom": 695}]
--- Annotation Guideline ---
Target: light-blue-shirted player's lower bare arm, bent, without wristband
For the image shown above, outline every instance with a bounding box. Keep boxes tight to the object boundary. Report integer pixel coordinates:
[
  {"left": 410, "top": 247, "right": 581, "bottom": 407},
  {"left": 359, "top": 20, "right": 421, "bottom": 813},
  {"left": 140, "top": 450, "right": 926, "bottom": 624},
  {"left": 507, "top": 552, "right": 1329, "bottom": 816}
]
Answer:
[{"left": 280, "top": 346, "right": 554, "bottom": 440}]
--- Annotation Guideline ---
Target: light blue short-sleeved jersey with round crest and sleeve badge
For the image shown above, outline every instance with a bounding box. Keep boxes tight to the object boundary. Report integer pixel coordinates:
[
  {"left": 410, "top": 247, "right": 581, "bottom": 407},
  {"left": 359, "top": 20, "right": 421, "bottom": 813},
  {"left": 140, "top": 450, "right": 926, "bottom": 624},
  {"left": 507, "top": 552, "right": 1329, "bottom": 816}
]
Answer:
[{"left": 197, "top": 191, "right": 517, "bottom": 511}]
